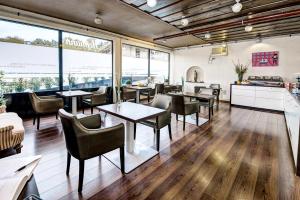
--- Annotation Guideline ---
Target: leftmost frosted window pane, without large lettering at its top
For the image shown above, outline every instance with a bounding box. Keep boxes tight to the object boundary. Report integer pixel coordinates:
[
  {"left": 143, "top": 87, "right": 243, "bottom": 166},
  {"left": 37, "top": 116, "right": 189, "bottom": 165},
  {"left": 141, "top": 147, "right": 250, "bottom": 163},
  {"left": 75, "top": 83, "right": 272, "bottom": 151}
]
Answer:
[{"left": 0, "top": 20, "right": 59, "bottom": 93}]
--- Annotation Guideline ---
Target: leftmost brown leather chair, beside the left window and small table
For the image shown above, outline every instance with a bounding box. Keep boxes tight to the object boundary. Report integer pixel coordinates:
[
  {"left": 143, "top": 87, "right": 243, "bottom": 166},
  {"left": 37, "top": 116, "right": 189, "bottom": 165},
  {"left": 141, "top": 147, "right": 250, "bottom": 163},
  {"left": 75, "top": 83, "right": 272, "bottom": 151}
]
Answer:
[{"left": 29, "top": 92, "right": 64, "bottom": 129}]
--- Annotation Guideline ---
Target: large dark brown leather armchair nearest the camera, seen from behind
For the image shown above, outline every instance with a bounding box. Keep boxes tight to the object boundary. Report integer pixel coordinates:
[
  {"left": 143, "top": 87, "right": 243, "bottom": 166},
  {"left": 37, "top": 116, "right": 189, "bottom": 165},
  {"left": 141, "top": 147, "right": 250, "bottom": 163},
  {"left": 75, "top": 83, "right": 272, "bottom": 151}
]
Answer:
[{"left": 59, "top": 109, "right": 125, "bottom": 192}]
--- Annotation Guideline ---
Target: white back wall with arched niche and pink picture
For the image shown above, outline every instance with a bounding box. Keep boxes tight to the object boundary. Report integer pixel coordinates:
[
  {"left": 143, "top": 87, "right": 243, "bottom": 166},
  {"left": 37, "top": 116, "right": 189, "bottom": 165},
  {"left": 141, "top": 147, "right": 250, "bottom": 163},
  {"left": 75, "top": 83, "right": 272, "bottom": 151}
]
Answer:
[{"left": 171, "top": 36, "right": 300, "bottom": 100}]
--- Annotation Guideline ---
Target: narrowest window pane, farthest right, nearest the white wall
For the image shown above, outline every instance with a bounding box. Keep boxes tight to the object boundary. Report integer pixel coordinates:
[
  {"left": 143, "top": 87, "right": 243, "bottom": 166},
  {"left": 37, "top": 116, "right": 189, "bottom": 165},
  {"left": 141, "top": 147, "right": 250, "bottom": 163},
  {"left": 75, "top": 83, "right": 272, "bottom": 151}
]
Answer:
[{"left": 150, "top": 50, "right": 169, "bottom": 83}]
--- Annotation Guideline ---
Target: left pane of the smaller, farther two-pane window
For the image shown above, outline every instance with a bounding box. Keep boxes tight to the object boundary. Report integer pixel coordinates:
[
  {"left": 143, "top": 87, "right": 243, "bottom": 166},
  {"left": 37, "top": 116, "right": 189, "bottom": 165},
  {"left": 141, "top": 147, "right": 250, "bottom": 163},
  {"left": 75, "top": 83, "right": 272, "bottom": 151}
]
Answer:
[{"left": 122, "top": 44, "right": 148, "bottom": 84}]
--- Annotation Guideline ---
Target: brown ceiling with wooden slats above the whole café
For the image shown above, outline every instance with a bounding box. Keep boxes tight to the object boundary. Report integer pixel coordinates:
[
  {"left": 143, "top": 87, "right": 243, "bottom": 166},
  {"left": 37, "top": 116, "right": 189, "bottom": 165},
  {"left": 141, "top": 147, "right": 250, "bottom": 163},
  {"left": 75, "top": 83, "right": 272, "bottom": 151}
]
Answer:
[{"left": 0, "top": 0, "right": 300, "bottom": 48}]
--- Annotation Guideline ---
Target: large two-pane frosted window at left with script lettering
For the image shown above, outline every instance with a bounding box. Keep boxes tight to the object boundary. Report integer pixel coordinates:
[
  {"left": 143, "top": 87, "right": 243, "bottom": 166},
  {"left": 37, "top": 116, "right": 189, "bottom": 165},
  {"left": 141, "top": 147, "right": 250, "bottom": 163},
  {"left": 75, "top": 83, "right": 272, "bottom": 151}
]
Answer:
[{"left": 0, "top": 20, "right": 112, "bottom": 93}]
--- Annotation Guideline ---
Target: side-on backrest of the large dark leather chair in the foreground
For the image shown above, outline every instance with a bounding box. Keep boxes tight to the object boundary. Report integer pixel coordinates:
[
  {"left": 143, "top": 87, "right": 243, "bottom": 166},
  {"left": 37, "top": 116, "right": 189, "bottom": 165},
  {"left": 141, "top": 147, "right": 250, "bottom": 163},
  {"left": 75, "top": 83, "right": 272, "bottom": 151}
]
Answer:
[{"left": 58, "top": 109, "right": 79, "bottom": 158}]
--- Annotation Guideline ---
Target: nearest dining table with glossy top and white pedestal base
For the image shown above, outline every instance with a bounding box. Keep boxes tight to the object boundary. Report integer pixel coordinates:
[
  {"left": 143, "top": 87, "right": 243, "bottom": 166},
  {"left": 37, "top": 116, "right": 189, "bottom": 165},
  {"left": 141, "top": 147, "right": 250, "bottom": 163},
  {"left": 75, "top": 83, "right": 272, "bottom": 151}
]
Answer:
[{"left": 97, "top": 102, "right": 166, "bottom": 173}]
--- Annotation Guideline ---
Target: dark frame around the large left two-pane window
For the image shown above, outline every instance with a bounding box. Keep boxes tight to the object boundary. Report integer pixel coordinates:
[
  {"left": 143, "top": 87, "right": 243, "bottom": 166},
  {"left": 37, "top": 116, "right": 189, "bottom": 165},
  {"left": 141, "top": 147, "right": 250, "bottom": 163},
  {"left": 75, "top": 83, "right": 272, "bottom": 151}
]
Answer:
[{"left": 0, "top": 17, "right": 114, "bottom": 94}]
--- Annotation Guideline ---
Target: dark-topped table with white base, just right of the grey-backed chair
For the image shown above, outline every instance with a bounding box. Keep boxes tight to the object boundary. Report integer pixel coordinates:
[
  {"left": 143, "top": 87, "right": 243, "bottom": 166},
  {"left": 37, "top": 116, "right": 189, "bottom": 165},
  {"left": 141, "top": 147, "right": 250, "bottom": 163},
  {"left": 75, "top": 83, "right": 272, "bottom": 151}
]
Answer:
[{"left": 168, "top": 92, "right": 216, "bottom": 126}]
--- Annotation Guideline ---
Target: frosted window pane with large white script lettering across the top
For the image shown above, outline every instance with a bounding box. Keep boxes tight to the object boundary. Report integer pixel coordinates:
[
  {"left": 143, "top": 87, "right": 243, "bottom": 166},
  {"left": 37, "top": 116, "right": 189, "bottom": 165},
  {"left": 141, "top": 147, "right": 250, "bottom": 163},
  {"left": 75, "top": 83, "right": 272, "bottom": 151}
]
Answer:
[{"left": 63, "top": 32, "right": 112, "bottom": 89}]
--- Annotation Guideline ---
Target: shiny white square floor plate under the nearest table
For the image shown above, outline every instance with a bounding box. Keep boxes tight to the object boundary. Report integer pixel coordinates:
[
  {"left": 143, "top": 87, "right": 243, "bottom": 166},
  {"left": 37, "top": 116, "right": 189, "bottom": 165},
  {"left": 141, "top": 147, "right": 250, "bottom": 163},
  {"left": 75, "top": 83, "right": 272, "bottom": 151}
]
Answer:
[{"left": 103, "top": 142, "right": 158, "bottom": 173}]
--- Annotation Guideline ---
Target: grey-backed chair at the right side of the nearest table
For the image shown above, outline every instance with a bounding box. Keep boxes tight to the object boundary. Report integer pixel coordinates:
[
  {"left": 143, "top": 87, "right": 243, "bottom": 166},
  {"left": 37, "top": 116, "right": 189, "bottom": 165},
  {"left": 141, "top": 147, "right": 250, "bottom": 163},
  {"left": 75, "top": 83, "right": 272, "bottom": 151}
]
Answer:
[{"left": 134, "top": 94, "right": 172, "bottom": 151}]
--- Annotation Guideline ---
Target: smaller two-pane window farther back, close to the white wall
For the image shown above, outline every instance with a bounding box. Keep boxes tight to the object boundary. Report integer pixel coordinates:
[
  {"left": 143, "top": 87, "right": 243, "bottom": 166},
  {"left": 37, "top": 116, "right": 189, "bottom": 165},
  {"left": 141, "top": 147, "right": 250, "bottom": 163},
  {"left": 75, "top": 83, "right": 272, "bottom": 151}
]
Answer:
[{"left": 122, "top": 44, "right": 169, "bottom": 84}]
